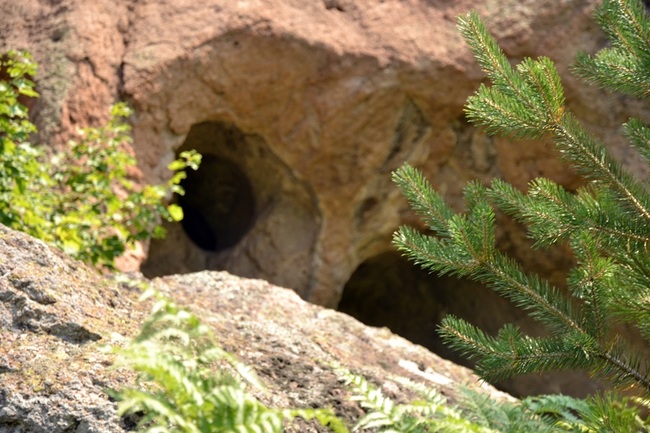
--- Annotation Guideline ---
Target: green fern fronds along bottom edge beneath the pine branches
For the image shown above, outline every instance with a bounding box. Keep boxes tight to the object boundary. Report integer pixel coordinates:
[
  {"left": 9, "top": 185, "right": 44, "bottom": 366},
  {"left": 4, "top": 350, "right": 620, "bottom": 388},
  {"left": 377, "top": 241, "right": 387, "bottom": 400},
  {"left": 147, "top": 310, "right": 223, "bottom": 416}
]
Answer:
[{"left": 338, "top": 369, "right": 649, "bottom": 433}]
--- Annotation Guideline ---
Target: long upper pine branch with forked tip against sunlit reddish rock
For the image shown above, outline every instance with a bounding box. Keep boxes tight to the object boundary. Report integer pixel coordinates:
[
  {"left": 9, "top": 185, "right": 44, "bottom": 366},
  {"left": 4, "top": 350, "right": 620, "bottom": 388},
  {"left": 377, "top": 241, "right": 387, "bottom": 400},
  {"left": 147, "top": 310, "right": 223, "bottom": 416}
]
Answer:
[{"left": 458, "top": 6, "right": 650, "bottom": 220}]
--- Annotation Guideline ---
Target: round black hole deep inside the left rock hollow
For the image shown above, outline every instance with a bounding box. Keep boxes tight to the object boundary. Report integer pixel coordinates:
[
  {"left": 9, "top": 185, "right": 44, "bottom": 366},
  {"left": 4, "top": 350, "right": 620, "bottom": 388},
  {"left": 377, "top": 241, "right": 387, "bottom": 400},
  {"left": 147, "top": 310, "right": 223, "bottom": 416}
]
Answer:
[{"left": 176, "top": 154, "right": 255, "bottom": 251}]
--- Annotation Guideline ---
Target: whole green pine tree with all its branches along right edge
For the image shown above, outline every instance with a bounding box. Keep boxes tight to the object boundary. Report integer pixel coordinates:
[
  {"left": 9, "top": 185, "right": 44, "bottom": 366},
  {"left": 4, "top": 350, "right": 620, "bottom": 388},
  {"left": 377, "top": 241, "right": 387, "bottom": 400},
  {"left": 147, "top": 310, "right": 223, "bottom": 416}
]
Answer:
[{"left": 393, "top": 0, "right": 650, "bottom": 397}]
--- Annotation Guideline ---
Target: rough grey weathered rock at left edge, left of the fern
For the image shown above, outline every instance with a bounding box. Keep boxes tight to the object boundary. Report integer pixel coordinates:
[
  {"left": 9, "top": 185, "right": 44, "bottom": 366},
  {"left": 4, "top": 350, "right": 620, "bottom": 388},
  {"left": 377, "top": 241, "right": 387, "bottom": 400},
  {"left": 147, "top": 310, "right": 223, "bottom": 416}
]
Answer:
[{"left": 0, "top": 227, "right": 138, "bottom": 433}]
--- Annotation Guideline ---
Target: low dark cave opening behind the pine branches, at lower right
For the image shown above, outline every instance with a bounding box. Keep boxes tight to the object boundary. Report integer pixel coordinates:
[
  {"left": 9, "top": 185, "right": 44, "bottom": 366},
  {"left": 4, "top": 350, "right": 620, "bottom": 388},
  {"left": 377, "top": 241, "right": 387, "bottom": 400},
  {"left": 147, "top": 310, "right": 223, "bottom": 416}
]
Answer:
[{"left": 338, "top": 251, "right": 599, "bottom": 397}]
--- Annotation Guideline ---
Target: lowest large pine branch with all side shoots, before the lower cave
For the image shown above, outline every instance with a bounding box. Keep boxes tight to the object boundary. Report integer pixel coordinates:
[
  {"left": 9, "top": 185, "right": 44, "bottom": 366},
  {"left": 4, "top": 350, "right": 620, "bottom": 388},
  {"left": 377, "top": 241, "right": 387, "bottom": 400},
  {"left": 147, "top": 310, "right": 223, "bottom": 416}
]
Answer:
[{"left": 394, "top": 162, "right": 645, "bottom": 392}]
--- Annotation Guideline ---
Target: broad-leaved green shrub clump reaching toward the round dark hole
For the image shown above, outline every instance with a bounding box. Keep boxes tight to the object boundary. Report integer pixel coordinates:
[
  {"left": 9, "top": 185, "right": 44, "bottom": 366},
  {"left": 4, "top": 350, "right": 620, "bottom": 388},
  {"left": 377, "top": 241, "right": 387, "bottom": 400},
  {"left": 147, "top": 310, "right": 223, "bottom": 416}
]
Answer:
[{"left": 46, "top": 103, "right": 201, "bottom": 266}]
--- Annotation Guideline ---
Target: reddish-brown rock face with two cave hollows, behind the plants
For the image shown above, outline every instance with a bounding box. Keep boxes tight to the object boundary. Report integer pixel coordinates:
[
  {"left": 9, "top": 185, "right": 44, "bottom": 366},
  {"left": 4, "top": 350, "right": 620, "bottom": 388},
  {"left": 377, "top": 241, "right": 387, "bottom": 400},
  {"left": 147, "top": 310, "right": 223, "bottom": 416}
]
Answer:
[{"left": 0, "top": 0, "right": 650, "bottom": 393}]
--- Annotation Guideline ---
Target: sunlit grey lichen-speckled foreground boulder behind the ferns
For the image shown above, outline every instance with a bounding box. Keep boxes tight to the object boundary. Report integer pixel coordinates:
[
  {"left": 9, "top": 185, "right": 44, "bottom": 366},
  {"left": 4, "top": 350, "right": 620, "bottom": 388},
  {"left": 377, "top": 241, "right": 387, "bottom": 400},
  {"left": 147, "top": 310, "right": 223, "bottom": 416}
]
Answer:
[{"left": 0, "top": 226, "right": 506, "bottom": 433}]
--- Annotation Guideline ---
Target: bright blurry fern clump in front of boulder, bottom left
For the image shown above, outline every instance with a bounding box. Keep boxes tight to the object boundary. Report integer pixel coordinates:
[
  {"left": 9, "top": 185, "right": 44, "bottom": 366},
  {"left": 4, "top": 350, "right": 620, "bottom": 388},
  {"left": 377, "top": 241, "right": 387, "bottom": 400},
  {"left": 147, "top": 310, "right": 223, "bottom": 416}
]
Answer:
[{"left": 109, "top": 290, "right": 348, "bottom": 433}]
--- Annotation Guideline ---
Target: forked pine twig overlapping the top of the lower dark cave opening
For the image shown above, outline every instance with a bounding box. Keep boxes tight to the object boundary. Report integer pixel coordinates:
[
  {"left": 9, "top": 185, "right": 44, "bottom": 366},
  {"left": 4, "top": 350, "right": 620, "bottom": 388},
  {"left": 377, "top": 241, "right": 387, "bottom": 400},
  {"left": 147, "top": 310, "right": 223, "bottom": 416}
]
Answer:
[{"left": 394, "top": 170, "right": 585, "bottom": 333}]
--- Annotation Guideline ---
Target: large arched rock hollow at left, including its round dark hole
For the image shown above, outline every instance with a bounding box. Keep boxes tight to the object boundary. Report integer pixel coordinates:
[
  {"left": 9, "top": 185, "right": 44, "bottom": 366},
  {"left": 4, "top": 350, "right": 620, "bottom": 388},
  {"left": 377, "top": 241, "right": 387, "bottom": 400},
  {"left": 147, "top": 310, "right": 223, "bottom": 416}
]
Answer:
[{"left": 140, "top": 121, "right": 320, "bottom": 295}]
